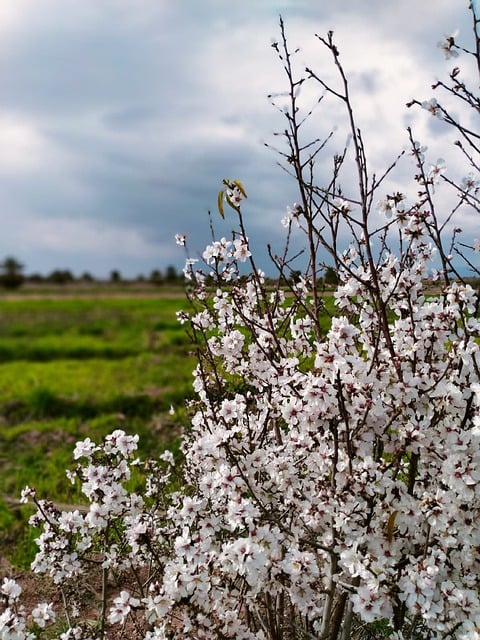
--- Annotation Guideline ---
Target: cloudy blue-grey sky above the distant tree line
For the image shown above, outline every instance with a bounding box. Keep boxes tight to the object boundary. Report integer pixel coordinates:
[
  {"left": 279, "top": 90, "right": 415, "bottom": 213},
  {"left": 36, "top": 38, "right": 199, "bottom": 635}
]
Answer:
[{"left": 0, "top": 0, "right": 478, "bottom": 278}]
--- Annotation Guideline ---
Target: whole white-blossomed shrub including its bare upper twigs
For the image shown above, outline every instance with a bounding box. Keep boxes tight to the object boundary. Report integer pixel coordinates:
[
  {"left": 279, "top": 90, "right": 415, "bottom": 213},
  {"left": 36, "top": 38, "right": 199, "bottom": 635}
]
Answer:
[{"left": 0, "top": 7, "right": 480, "bottom": 640}]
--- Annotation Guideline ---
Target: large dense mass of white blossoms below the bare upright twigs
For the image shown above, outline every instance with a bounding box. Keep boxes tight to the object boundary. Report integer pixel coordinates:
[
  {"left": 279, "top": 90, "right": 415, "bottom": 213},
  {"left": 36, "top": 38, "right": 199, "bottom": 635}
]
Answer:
[{"left": 165, "top": 222, "right": 480, "bottom": 637}]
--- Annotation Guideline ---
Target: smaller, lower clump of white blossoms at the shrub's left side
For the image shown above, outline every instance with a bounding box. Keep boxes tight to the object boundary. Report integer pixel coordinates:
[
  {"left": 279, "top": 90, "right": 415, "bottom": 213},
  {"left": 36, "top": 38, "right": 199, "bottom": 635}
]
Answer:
[{"left": 0, "top": 430, "right": 179, "bottom": 640}]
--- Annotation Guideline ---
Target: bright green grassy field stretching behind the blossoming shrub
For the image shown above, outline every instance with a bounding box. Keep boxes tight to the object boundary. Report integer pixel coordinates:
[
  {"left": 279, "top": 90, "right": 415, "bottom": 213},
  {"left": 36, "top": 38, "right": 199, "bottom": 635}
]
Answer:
[{"left": 0, "top": 292, "right": 194, "bottom": 566}]
